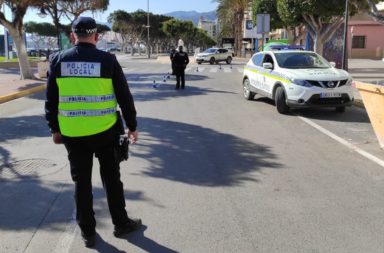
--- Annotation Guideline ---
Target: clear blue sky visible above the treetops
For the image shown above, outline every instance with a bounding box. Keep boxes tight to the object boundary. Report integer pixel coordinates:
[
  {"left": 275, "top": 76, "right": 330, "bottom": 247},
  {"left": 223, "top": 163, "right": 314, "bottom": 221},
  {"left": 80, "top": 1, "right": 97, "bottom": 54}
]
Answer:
[{"left": 24, "top": 0, "right": 218, "bottom": 23}]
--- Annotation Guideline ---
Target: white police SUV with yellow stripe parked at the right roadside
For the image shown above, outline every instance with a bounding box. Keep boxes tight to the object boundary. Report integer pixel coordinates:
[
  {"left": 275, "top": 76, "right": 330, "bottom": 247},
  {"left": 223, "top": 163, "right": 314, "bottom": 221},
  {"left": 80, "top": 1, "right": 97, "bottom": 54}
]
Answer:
[{"left": 243, "top": 50, "right": 354, "bottom": 114}]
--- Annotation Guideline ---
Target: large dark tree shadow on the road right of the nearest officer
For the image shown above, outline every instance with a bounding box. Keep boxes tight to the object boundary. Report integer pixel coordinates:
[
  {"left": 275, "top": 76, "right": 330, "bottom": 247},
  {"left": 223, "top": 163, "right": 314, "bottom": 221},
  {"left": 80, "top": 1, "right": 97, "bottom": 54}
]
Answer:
[{"left": 133, "top": 118, "right": 283, "bottom": 187}]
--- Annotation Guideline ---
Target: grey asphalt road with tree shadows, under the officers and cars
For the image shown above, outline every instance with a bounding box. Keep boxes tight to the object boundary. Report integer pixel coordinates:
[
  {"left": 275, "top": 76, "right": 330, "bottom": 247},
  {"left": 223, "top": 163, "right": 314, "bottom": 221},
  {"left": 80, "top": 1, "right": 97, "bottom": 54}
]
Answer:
[{"left": 0, "top": 59, "right": 384, "bottom": 253}]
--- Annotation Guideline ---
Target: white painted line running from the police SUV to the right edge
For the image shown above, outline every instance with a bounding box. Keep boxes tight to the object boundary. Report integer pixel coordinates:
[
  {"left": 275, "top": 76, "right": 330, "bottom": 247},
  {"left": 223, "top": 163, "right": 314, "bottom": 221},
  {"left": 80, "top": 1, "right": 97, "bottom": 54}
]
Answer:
[{"left": 298, "top": 116, "right": 384, "bottom": 167}]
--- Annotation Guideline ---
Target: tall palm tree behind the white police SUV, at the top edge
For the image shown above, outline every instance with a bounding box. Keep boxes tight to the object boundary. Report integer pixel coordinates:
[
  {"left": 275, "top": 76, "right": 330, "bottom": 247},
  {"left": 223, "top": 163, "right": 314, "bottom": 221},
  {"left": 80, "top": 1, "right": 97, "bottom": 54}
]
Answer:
[{"left": 213, "top": 0, "right": 252, "bottom": 55}]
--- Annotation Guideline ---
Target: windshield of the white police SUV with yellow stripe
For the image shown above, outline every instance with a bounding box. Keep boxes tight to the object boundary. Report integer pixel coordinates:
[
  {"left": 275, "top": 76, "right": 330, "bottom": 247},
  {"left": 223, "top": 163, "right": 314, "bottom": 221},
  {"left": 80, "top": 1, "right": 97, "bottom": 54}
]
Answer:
[{"left": 275, "top": 52, "right": 331, "bottom": 69}]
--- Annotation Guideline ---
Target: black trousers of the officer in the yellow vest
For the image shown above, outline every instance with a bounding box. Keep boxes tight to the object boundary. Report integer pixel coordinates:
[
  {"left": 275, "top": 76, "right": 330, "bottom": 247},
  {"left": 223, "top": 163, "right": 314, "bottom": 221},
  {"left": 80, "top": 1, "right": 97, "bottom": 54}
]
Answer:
[{"left": 63, "top": 126, "right": 128, "bottom": 234}]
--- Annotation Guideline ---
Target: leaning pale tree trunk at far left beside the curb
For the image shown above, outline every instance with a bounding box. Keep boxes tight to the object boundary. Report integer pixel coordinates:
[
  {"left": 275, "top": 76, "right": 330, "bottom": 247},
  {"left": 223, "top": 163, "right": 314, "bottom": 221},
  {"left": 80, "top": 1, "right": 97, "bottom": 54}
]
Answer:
[{"left": 8, "top": 27, "right": 34, "bottom": 79}]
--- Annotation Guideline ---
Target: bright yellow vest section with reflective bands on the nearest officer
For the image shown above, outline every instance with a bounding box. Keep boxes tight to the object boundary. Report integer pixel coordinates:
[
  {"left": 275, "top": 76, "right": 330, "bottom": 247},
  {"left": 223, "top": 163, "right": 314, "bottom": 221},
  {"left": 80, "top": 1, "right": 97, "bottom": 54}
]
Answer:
[{"left": 56, "top": 75, "right": 117, "bottom": 137}]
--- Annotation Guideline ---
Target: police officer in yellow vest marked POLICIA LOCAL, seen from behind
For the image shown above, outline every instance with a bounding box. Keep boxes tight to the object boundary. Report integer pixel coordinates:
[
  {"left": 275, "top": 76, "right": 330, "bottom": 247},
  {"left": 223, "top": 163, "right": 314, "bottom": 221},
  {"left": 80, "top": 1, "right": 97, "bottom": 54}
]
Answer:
[{"left": 45, "top": 17, "right": 142, "bottom": 247}]
